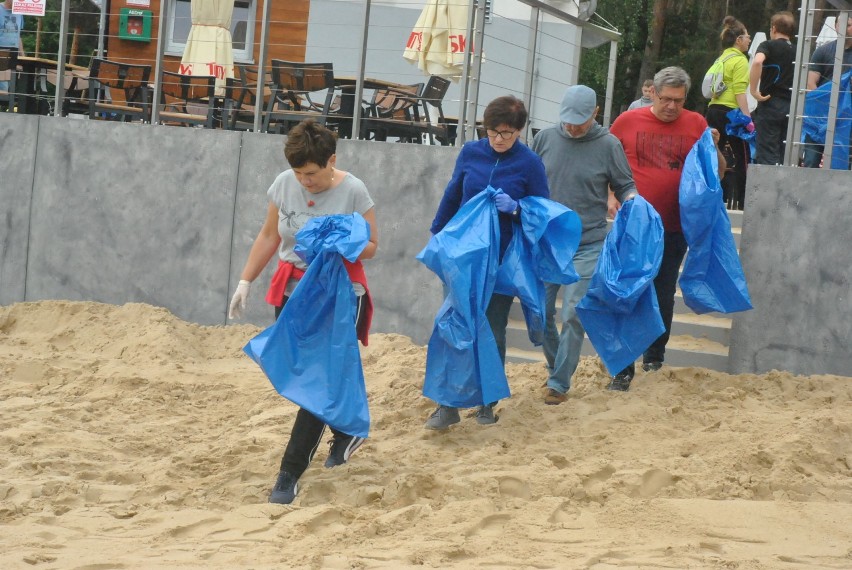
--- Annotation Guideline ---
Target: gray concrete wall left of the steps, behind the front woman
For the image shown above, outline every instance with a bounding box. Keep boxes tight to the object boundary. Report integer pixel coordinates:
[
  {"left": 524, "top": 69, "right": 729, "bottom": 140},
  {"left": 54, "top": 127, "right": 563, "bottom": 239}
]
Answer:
[{"left": 0, "top": 113, "right": 458, "bottom": 344}]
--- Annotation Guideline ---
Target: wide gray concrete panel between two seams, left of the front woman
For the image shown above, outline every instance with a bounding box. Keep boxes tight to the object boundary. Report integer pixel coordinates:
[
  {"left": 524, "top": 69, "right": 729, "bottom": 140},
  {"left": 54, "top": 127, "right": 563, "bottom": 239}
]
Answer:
[{"left": 27, "top": 117, "right": 240, "bottom": 324}]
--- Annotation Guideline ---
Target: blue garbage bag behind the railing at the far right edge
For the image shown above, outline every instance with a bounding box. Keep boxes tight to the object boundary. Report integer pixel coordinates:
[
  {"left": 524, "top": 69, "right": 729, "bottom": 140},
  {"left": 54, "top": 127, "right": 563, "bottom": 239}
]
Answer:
[{"left": 802, "top": 71, "right": 852, "bottom": 170}]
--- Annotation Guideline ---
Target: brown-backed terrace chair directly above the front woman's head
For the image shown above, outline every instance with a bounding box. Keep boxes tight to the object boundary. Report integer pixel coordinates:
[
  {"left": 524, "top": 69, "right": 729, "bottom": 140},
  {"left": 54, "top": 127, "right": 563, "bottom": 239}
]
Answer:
[{"left": 263, "top": 59, "right": 335, "bottom": 133}]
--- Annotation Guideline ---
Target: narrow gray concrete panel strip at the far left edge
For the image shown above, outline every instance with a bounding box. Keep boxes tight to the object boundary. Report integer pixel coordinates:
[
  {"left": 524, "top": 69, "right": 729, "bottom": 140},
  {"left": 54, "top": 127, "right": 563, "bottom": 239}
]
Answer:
[{"left": 0, "top": 113, "right": 38, "bottom": 305}]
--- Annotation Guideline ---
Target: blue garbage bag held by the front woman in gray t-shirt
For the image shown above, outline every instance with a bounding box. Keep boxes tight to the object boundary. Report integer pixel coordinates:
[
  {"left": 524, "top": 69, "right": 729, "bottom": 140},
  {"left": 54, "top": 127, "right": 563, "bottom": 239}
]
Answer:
[{"left": 243, "top": 213, "right": 370, "bottom": 437}]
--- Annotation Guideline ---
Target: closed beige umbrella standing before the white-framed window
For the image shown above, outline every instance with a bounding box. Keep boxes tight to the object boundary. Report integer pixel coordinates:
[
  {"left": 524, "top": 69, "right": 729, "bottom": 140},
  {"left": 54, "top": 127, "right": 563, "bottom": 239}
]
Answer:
[{"left": 180, "top": 0, "right": 234, "bottom": 95}]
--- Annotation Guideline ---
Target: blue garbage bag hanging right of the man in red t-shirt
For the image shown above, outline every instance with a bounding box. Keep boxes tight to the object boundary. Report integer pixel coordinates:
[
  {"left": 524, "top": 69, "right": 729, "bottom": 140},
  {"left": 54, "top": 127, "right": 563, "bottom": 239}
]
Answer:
[{"left": 679, "top": 129, "right": 752, "bottom": 314}]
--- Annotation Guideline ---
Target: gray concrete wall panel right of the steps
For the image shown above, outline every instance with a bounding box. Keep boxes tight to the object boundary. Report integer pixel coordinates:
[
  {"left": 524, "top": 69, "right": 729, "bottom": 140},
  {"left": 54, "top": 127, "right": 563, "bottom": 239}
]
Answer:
[{"left": 730, "top": 165, "right": 852, "bottom": 376}]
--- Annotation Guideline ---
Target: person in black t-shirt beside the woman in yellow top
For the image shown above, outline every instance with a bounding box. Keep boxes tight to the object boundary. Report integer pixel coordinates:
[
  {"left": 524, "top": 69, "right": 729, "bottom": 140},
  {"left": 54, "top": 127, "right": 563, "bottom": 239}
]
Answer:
[{"left": 749, "top": 12, "right": 796, "bottom": 164}]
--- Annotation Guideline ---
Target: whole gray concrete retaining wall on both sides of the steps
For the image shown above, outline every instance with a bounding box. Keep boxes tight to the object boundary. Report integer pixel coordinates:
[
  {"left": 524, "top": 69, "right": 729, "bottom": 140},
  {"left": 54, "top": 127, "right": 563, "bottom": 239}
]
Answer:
[{"left": 0, "top": 113, "right": 852, "bottom": 375}]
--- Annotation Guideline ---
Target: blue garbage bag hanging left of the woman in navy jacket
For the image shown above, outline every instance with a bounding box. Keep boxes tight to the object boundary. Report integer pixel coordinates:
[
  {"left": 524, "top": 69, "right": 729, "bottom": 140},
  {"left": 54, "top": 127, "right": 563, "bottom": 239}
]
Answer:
[{"left": 417, "top": 186, "right": 510, "bottom": 408}]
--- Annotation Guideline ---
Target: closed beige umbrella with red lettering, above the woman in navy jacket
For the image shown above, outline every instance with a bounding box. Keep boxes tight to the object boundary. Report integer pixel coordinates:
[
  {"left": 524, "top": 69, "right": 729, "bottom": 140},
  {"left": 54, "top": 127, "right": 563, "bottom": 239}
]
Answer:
[{"left": 402, "top": 0, "right": 470, "bottom": 79}]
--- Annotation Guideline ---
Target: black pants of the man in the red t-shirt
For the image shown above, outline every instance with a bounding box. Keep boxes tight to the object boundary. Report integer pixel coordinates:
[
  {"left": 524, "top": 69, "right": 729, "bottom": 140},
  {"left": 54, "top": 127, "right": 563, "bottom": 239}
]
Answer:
[{"left": 623, "top": 232, "right": 687, "bottom": 376}]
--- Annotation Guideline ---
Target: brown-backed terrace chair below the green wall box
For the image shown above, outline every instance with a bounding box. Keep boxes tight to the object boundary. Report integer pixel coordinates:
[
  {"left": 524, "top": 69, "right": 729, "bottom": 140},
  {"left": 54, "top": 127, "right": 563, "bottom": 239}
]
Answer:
[{"left": 89, "top": 57, "right": 151, "bottom": 122}]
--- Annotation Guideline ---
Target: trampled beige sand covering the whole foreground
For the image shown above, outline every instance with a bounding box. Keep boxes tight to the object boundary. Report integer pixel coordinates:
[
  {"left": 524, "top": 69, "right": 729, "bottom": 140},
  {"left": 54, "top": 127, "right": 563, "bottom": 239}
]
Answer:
[{"left": 0, "top": 301, "right": 852, "bottom": 570}]
